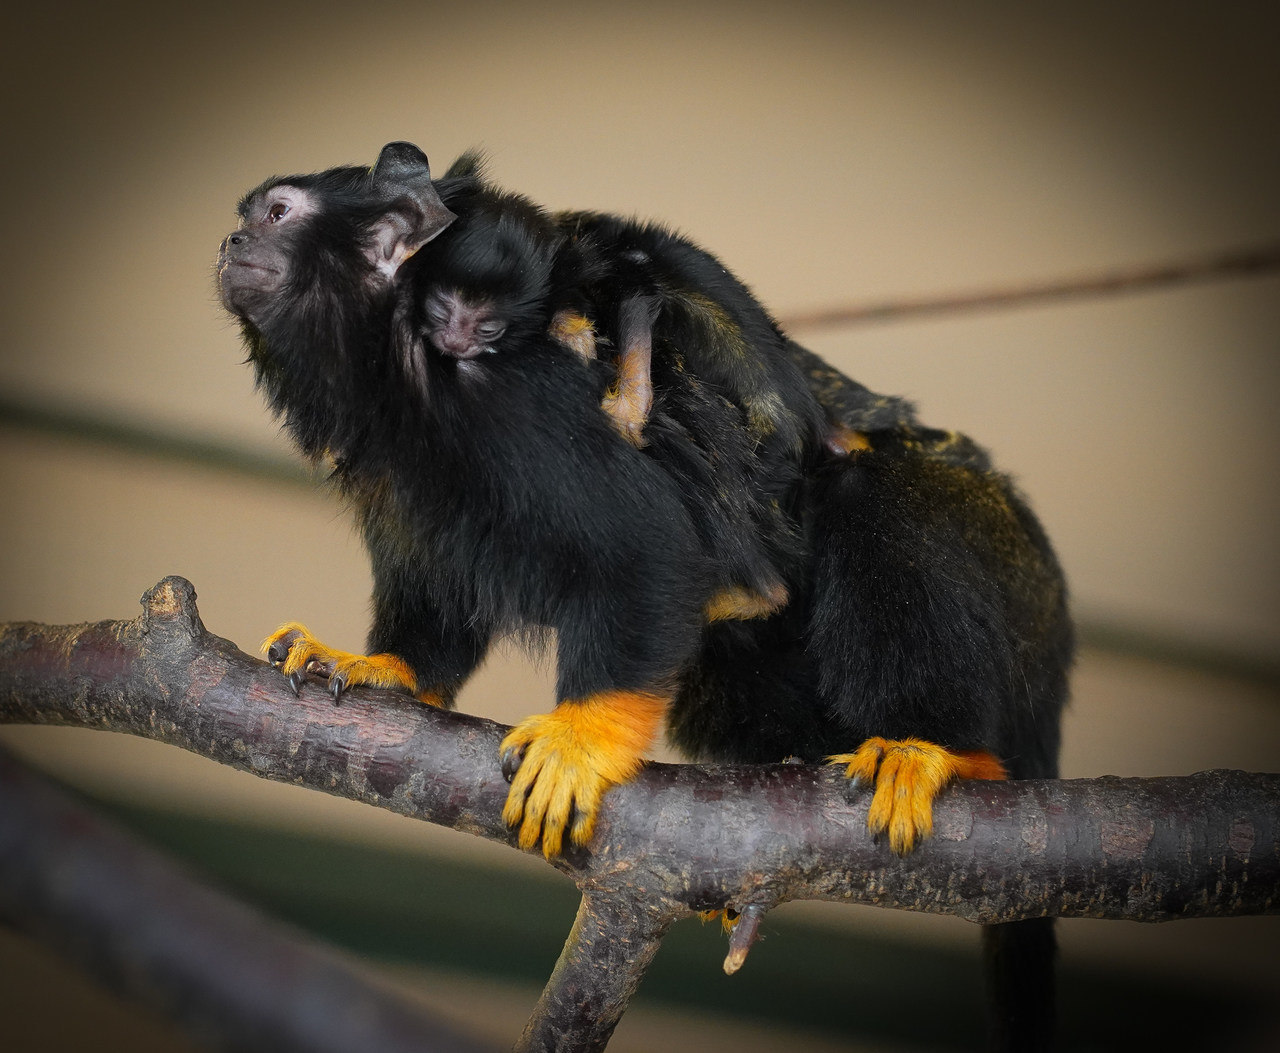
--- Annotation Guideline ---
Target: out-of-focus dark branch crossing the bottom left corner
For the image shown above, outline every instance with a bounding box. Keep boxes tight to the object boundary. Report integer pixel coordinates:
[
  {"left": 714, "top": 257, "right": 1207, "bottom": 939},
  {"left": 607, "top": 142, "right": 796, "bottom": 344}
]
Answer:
[{"left": 0, "top": 750, "right": 485, "bottom": 1053}]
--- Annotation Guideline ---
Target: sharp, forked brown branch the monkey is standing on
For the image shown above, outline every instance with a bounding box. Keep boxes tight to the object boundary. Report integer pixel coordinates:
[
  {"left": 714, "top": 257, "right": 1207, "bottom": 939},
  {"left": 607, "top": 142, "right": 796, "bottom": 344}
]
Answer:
[{"left": 0, "top": 577, "right": 1280, "bottom": 1049}]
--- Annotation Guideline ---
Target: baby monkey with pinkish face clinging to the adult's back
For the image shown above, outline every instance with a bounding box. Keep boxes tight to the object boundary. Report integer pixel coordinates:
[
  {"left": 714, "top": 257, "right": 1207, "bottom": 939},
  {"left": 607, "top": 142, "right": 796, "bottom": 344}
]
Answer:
[{"left": 411, "top": 155, "right": 814, "bottom": 621}]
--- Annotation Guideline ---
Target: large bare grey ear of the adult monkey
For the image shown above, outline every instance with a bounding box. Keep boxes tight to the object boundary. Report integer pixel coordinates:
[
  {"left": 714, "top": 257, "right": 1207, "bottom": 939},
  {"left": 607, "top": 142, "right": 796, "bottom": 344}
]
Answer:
[{"left": 369, "top": 142, "right": 457, "bottom": 279}]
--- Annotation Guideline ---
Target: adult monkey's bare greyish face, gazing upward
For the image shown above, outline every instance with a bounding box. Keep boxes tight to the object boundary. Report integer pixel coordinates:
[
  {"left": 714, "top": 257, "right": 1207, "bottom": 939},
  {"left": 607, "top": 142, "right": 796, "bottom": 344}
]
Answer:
[{"left": 218, "top": 183, "right": 317, "bottom": 324}]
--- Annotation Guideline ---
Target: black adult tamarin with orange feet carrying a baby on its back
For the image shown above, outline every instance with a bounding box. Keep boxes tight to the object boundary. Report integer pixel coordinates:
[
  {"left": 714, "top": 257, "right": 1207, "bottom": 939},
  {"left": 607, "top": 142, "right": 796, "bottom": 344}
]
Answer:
[{"left": 219, "top": 143, "right": 1071, "bottom": 1049}]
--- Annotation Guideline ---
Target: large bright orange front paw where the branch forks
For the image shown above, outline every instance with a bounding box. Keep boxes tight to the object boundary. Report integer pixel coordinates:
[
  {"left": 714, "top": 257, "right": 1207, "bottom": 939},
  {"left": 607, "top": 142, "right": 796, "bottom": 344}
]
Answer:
[{"left": 499, "top": 691, "right": 668, "bottom": 859}]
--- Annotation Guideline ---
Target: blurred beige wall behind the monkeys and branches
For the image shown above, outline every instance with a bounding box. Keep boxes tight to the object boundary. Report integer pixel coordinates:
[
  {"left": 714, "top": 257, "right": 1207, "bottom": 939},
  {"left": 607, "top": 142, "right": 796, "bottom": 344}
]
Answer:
[{"left": 0, "top": 0, "right": 1280, "bottom": 1049}]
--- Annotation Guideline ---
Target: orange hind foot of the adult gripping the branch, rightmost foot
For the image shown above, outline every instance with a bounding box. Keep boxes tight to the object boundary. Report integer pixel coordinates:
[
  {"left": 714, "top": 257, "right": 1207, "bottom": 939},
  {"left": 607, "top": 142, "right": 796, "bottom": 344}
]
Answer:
[{"left": 827, "top": 738, "right": 1009, "bottom": 856}]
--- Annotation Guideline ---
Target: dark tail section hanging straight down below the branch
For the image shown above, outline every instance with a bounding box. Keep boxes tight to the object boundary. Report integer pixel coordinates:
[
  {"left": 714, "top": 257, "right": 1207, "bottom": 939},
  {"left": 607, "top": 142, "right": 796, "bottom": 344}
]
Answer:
[{"left": 982, "top": 917, "right": 1056, "bottom": 1053}]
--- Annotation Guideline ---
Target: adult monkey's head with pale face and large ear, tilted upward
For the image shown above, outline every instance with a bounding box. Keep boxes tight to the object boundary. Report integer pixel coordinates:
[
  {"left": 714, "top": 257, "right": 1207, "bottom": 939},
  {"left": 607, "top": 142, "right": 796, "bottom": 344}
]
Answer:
[{"left": 218, "top": 142, "right": 454, "bottom": 345}]
